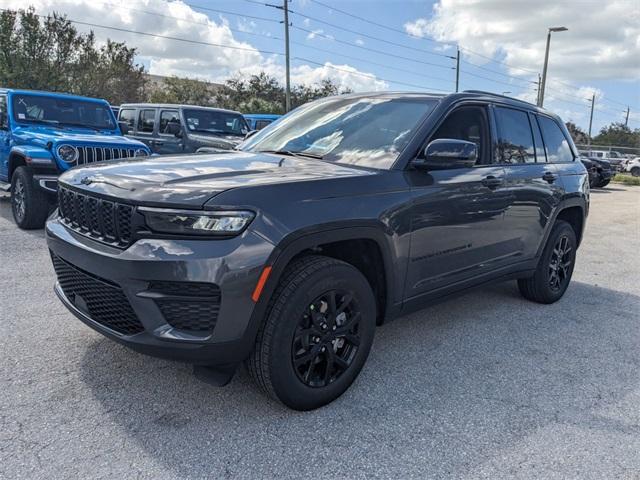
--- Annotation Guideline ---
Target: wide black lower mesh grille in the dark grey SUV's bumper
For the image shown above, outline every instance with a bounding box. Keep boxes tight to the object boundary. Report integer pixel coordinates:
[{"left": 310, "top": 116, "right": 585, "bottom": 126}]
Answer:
[{"left": 51, "top": 252, "right": 144, "bottom": 335}]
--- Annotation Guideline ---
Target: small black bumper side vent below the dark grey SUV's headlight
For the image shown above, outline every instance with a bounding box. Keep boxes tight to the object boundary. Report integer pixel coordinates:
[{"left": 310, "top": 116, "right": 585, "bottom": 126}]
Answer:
[{"left": 149, "top": 282, "right": 221, "bottom": 333}]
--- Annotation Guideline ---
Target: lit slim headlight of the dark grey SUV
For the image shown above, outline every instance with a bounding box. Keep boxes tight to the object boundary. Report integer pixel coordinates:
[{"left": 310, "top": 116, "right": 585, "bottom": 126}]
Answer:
[{"left": 139, "top": 207, "right": 255, "bottom": 235}]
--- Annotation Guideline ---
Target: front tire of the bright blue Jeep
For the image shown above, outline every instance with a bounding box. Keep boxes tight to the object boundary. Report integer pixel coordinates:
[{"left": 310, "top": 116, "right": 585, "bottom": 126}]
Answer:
[{"left": 11, "top": 167, "right": 50, "bottom": 230}]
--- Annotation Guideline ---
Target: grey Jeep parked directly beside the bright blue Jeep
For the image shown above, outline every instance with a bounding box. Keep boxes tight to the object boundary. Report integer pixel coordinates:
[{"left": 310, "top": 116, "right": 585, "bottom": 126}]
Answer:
[{"left": 118, "top": 103, "right": 249, "bottom": 155}]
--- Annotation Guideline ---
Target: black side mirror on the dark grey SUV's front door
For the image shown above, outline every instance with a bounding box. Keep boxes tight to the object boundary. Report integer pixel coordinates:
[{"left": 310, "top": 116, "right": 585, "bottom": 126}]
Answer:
[{"left": 415, "top": 138, "right": 478, "bottom": 170}]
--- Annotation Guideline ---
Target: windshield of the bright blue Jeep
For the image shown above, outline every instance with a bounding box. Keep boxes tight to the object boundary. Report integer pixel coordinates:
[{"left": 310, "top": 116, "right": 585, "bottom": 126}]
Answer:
[{"left": 12, "top": 95, "right": 115, "bottom": 130}]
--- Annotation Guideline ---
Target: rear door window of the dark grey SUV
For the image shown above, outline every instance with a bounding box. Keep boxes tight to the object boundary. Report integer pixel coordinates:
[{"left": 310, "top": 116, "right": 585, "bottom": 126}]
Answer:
[{"left": 495, "top": 107, "right": 536, "bottom": 163}]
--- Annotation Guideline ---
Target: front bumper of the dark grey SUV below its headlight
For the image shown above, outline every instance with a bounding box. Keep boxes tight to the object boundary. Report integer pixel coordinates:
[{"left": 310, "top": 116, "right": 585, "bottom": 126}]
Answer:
[{"left": 46, "top": 217, "right": 273, "bottom": 365}]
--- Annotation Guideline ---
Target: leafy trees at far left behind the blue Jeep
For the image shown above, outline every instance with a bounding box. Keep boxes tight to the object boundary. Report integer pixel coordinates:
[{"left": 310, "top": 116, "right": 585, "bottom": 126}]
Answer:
[{"left": 0, "top": 8, "right": 146, "bottom": 104}]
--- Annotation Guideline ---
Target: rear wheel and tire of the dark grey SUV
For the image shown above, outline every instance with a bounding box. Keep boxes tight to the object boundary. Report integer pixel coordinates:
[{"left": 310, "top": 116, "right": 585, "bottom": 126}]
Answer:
[{"left": 518, "top": 220, "right": 577, "bottom": 303}]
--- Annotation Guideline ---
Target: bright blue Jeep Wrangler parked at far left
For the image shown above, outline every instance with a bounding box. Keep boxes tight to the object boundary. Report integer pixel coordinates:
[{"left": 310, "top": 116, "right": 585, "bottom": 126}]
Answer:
[{"left": 0, "top": 89, "right": 150, "bottom": 229}]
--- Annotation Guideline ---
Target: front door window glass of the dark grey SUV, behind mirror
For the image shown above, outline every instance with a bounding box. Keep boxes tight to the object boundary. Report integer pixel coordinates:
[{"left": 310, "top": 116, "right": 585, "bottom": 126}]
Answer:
[{"left": 429, "top": 107, "right": 491, "bottom": 165}]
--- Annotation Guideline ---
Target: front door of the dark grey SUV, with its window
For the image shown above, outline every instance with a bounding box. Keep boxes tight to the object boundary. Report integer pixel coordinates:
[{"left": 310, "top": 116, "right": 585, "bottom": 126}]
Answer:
[{"left": 405, "top": 106, "right": 510, "bottom": 299}]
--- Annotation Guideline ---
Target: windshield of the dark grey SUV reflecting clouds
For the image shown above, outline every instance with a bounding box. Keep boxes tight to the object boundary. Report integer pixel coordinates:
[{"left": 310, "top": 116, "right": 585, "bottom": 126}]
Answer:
[{"left": 241, "top": 96, "right": 437, "bottom": 169}]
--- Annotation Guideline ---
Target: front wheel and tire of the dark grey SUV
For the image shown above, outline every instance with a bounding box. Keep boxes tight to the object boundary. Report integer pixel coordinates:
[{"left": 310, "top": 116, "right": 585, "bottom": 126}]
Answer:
[{"left": 246, "top": 255, "right": 376, "bottom": 410}]
